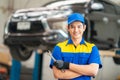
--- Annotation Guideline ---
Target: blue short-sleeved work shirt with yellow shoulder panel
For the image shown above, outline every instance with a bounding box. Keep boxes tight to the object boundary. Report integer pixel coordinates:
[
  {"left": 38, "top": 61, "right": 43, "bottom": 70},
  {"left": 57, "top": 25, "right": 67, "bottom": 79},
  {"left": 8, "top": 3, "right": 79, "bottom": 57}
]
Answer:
[{"left": 50, "top": 39, "right": 102, "bottom": 80}]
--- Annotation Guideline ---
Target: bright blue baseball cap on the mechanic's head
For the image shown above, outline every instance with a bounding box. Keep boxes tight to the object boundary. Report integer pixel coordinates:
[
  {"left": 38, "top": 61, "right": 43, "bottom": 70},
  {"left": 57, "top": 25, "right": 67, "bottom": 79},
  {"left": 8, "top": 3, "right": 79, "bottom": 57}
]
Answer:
[{"left": 68, "top": 13, "right": 85, "bottom": 25}]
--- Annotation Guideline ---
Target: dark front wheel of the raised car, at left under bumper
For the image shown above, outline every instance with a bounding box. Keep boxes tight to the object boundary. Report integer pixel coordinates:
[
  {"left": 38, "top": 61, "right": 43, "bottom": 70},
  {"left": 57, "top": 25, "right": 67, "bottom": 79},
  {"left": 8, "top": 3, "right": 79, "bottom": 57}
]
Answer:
[{"left": 9, "top": 46, "right": 33, "bottom": 61}]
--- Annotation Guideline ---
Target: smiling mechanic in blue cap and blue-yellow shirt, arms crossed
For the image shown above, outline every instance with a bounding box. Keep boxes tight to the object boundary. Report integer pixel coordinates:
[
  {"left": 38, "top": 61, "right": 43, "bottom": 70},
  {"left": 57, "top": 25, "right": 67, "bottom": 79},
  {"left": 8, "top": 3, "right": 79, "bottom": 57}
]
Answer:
[{"left": 50, "top": 13, "right": 102, "bottom": 80}]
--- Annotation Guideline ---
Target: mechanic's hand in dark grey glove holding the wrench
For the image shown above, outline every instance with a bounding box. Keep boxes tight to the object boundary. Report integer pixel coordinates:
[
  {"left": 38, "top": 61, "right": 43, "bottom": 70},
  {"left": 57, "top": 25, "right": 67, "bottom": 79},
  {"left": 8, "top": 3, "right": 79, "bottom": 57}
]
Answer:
[{"left": 54, "top": 60, "right": 69, "bottom": 70}]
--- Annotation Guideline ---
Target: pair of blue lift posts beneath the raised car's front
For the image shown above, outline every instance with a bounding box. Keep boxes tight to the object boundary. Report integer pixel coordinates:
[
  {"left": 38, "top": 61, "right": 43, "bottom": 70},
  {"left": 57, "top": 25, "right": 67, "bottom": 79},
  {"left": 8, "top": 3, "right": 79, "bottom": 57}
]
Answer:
[{"left": 10, "top": 51, "right": 43, "bottom": 80}]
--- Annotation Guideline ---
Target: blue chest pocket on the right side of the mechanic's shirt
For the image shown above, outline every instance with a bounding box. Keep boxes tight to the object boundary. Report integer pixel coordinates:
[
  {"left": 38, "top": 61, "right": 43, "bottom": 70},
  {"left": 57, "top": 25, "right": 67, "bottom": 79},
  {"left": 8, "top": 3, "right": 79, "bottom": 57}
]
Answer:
[{"left": 78, "top": 54, "right": 89, "bottom": 64}]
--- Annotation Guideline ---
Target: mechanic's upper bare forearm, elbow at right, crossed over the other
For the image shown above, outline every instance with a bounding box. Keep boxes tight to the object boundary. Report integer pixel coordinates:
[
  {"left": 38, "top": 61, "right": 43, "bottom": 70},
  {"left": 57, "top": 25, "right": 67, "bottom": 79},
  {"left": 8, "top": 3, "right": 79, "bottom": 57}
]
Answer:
[{"left": 69, "top": 63, "right": 99, "bottom": 76}]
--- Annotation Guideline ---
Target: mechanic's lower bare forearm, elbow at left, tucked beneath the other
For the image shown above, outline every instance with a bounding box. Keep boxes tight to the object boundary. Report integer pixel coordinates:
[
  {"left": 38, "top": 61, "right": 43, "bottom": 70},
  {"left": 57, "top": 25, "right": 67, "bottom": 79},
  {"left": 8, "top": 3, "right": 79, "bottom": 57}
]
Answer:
[{"left": 53, "top": 66, "right": 81, "bottom": 79}]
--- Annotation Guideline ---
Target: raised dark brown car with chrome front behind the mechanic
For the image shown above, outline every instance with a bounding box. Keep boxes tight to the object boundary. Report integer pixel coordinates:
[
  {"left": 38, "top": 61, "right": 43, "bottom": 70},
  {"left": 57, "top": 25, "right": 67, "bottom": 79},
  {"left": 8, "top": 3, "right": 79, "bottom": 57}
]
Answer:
[{"left": 4, "top": 0, "right": 120, "bottom": 62}]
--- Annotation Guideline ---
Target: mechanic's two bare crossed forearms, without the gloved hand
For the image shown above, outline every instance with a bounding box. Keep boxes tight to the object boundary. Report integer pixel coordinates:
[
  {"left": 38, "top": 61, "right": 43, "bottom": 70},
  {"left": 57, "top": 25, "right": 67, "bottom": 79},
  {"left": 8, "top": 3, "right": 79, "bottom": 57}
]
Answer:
[{"left": 53, "top": 63, "right": 99, "bottom": 79}]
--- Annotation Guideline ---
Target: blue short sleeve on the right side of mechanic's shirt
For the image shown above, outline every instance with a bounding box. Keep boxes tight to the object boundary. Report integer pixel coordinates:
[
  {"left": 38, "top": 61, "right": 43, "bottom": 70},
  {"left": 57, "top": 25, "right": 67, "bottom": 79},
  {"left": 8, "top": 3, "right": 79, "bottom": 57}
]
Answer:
[{"left": 88, "top": 46, "right": 102, "bottom": 68}]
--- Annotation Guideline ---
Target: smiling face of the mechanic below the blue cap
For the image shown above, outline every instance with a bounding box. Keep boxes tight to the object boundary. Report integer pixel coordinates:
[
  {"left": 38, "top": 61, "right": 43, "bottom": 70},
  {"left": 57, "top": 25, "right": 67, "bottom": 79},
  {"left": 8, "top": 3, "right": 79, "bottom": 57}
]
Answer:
[{"left": 68, "top": 21, "right": 86, "bottom": 39}]
